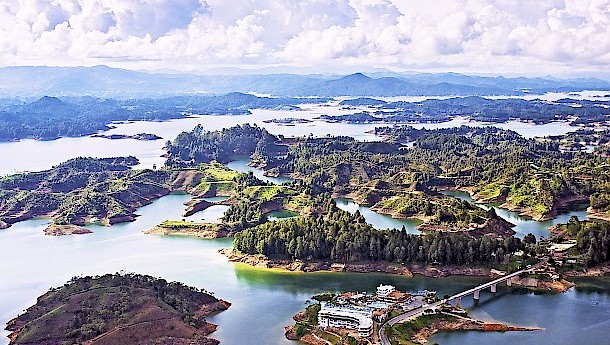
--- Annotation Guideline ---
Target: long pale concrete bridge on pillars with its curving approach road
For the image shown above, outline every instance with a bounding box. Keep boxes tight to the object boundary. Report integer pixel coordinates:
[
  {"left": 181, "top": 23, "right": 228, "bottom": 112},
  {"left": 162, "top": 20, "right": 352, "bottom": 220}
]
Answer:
[{"left": 378, "top": 267, "right": 534, "bottom": 345}]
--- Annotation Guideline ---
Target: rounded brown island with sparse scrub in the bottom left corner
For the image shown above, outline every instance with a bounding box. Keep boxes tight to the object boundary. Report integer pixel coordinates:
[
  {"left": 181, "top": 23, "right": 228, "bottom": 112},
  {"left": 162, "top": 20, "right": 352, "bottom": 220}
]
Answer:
[{"left": 6, "top": 273, "right": 230, "bottom": 345}]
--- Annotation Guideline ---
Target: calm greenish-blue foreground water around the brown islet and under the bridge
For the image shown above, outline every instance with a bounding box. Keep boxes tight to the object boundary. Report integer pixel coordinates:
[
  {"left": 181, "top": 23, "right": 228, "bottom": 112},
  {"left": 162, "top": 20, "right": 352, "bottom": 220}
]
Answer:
[{"left": 0, "top": 195, "right": 610, "bottom": 345}]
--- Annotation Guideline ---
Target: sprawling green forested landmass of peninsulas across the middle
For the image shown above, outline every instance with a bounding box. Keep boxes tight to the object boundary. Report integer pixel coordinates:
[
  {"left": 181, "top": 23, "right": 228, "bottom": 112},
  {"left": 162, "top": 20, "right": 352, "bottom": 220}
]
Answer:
[{"left": 0, "top": 121, "right": 610, "bottom": 280}]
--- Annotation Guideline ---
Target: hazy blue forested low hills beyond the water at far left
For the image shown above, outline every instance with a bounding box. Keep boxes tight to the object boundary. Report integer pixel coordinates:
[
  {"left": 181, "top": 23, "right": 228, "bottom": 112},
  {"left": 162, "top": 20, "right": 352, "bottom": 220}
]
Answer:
[{"left": 0, "top": 92, "right": 327, "bottom": 142}]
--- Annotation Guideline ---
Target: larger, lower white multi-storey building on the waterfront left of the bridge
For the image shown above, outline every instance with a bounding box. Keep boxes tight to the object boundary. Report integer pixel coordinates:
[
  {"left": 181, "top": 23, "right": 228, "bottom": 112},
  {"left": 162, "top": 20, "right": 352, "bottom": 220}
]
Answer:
[{"left": 318, "top": 302, "right": 373, "bottom": 338}]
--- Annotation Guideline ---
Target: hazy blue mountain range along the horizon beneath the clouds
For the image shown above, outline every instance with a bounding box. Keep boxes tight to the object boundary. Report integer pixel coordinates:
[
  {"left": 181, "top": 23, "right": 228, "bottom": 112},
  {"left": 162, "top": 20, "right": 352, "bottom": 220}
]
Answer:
[{"left": 0, "top": 66, "right": 610, "bottom": 98}]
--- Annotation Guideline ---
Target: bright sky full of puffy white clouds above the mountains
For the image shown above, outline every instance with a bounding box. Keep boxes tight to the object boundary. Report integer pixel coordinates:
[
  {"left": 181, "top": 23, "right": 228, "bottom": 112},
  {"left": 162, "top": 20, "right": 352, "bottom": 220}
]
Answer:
[{"left": 0, "top": 0, "right": 610, "bottom": 75}]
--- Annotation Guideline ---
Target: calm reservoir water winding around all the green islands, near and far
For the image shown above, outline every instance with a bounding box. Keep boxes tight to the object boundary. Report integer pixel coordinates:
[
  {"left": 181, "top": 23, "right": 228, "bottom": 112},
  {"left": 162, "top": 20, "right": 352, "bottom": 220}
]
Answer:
[{"left": 0, "top": 92, "right": 610, "bottom": 345}]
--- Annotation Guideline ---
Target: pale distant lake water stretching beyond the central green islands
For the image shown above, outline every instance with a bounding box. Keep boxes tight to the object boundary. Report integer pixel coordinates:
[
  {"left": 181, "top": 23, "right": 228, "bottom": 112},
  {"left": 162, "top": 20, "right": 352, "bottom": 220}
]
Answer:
[{"left": 0, "top": 97, "right": 596, "bottom": 176}]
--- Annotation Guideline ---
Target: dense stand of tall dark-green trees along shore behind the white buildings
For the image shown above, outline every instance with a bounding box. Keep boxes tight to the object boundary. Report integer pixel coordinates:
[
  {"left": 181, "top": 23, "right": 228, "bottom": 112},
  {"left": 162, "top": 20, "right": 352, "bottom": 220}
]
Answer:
[{"left": 234, "top": 200, "right": 524, "bottom": 265}]
